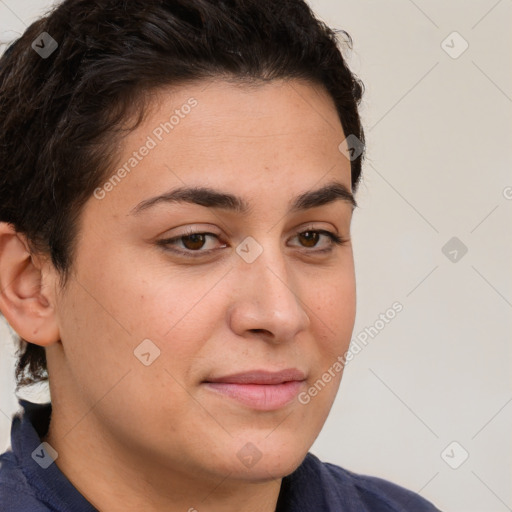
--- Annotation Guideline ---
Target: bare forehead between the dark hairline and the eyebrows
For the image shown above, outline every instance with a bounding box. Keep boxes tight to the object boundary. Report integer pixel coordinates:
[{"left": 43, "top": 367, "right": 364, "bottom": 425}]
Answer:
[{"left": 88, "top": 80, "right": 354, "bottom": 222}]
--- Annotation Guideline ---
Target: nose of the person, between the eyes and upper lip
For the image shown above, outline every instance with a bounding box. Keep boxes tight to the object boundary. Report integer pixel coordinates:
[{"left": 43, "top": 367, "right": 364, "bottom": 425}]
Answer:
[{"left": 229, "top": 243, "right": 310, "bottom": 343}]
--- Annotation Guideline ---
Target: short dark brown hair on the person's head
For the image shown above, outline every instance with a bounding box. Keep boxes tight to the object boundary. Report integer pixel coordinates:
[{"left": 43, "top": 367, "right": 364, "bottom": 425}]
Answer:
[{"left": 0, "top": 0, "right": 364, "bottom": 388}]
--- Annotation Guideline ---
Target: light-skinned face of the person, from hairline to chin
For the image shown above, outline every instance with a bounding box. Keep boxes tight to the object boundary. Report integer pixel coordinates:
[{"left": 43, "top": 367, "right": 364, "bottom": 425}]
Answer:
[{"left": 48, "top": 81, "right": 355, "bottom": 481}]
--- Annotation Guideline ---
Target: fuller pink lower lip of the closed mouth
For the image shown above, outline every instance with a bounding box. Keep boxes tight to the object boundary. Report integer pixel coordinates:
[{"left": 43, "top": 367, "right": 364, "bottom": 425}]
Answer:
[{"left": 205, "top": 380, "right": 304, "bottom": 411}]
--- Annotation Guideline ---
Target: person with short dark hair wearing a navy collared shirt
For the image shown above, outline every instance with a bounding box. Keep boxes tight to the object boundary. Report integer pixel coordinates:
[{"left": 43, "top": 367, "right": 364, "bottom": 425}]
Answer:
[{"left": 0, "top": 0, "right": 437, "bottom": 512}]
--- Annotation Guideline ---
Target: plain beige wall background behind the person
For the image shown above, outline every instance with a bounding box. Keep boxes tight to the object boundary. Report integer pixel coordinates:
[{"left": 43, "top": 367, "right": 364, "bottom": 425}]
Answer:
[{"left": 0, "top": 0, "right": 512, "bottom": 512}]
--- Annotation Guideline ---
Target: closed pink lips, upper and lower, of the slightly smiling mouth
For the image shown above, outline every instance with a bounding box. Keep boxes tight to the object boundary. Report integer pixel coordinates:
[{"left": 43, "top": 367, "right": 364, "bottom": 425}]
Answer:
[{"left": 204, "top": 368, "right": 306, "bottom": 411}]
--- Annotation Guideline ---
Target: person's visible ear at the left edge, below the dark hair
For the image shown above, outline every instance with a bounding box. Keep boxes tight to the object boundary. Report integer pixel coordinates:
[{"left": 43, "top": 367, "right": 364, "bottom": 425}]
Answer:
[{"left": 0, "top": 222, "right": 60, "bottom": 346}]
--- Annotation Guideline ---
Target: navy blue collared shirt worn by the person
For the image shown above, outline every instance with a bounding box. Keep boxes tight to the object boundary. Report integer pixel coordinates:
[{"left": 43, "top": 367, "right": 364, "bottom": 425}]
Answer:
[{"left": 0, "top": 400, "right": 439, "bottom": 512}]
